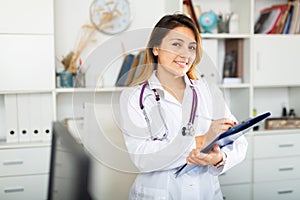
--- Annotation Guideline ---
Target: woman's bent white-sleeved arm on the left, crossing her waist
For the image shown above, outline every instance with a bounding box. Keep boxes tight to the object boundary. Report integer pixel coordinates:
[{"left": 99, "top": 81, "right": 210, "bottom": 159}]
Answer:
[{"left": 120, "top": 88, "right": 194, "bottom": 172}]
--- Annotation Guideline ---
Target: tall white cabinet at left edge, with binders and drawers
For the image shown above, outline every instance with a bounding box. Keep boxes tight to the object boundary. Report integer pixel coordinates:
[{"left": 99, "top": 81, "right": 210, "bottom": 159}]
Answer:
[{"left": 0, "top": 0, "right": 55, "bottom": 200}]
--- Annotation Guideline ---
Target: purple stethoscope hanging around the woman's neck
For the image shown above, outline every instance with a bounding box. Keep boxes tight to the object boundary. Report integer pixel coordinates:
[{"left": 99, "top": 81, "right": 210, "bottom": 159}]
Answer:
[{"left": 139, "top": 80, "right": 198, "bottom": 141}]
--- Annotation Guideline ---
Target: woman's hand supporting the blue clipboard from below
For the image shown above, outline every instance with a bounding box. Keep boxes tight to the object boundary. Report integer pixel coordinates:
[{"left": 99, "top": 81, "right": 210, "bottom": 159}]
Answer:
[{"left": 186, "top": 144, "right": 223, "bottom": 166}]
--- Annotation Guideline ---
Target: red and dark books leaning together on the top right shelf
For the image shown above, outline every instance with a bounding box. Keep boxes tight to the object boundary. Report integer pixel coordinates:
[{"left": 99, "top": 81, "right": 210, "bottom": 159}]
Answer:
[{"left": 254, "top": 0, "right": 300, "bottom": 34}]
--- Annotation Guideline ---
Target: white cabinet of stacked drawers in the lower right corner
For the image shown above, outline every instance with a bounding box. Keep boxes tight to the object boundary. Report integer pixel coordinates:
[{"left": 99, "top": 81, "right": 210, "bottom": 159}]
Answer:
[{"left": 253, "top": 130, "right": 300, "bottom": 199}]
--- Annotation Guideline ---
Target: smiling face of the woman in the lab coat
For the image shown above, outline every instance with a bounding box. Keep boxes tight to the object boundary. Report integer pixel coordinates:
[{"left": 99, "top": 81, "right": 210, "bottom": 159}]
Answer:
[{"left": 153, "top": 27, "right": 197, "bottom": 77}]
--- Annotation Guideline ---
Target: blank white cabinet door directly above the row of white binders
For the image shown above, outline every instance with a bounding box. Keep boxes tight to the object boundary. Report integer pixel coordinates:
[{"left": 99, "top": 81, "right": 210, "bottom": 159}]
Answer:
[{"left": 0, "top": 34, "right": 55, "bottom": 90}]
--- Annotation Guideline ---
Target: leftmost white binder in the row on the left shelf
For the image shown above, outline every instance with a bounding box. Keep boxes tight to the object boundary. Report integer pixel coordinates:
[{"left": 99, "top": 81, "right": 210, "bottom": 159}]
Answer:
[{"left": 4, "top": 94, "right": 19, "bottom": 143}]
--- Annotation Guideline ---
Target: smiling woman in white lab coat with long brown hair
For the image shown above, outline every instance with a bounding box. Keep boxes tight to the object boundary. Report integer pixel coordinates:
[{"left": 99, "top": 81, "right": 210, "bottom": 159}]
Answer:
[{"left": 120, "top": 14, "right": 247, "bottom": 200}]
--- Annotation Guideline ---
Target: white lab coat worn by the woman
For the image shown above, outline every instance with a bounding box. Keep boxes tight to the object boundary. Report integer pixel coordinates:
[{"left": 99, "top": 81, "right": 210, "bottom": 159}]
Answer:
[{"left": 120, "top": 72, "right": 247, "bottom": 200}]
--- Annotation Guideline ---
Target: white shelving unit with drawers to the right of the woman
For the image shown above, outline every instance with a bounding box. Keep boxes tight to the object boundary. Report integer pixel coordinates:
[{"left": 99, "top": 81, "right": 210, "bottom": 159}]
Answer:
[{"left": 194, "top": 0, "right": 300, "bottom": 200}]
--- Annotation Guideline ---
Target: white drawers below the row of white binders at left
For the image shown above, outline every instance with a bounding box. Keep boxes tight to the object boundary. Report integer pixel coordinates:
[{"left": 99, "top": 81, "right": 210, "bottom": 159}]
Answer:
[{"left": 0, "top": 144, "right": 50, "bottom": 200}]
